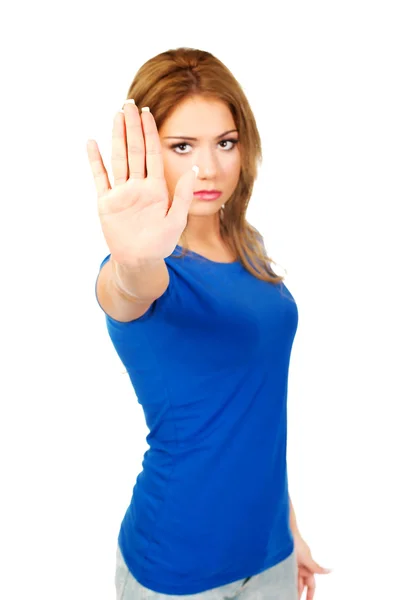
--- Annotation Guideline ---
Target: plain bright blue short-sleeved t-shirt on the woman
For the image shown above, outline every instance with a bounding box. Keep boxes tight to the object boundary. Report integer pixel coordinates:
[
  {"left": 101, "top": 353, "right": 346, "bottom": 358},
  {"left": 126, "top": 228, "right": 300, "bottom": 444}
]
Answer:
[{"left": 95, "top": 246, "right": 298, "bottom": 595}]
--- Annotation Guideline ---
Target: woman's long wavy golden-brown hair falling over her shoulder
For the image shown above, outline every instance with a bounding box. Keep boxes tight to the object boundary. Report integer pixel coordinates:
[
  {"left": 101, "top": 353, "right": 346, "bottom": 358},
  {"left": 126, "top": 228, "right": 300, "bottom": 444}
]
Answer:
[{"left": 123, "top": 48, "right": 284, "bottom": 283}]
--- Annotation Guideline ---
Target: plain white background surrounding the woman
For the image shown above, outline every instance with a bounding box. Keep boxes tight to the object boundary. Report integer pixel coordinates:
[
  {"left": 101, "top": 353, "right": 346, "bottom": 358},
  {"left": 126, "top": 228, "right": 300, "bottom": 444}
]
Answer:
[{"left": 0, "top": 0, "right": 400, "bottom": 600}]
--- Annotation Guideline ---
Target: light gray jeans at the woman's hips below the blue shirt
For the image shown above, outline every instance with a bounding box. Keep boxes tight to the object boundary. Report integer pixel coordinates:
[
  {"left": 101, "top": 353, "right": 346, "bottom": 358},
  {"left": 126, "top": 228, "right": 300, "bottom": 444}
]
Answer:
[{"left": 115, "top": 545, "right": 298, "bottom": 600}]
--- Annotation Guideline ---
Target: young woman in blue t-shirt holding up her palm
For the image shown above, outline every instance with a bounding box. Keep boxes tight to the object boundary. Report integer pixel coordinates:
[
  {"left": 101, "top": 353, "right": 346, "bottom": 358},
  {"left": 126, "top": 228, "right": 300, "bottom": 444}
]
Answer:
[{"left": 87, "top": 48, "right": 332, "bottom": 600}]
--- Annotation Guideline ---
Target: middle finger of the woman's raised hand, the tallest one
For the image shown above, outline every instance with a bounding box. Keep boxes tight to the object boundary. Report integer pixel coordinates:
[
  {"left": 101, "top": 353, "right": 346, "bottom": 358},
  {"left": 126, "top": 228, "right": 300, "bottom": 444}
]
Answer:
[{"left": 124, "top": 99, "right": 146, "bottom": 179}]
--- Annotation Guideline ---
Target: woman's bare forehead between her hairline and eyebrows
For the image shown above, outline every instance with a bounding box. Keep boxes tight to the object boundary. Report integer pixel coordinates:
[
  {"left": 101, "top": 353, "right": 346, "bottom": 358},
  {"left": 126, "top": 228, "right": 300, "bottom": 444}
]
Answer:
[{"left": 160, "top": 96, "right": 235, "bottom": 137}]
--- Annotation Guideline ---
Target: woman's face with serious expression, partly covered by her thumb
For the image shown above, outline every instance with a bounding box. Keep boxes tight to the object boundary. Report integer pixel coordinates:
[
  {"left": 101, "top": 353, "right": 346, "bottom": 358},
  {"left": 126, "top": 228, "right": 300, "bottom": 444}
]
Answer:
[{"left": 159, "top": 96, "right": 241, "bottom": 215}]
